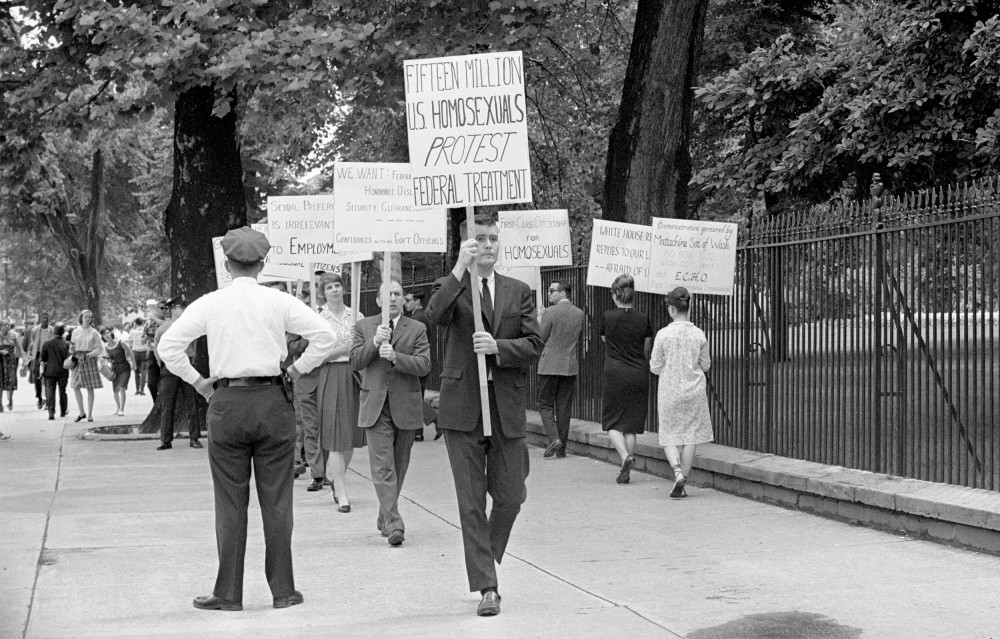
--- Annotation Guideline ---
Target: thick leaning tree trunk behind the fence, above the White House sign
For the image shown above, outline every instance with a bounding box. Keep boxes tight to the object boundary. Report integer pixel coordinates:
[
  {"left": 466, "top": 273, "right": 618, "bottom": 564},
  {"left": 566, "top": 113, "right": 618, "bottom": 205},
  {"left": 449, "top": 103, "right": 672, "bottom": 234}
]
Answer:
[{"left": 603, "top": 0, "right": 708, "bottom": 224}]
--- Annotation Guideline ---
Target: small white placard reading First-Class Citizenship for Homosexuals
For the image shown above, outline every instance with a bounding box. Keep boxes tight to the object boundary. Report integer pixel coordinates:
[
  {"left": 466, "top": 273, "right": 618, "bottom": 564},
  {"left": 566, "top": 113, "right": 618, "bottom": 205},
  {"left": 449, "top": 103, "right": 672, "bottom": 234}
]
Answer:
[{"left": 497, "top": 209, "right": 573, "bottom": 266}]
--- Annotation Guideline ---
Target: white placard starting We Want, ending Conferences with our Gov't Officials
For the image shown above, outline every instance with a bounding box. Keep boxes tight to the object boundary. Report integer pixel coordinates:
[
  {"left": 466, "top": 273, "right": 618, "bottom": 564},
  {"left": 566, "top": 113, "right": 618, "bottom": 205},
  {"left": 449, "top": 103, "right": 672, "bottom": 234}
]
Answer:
[{"left": 333, "top": 162, "right": 448, "bottom": 253}]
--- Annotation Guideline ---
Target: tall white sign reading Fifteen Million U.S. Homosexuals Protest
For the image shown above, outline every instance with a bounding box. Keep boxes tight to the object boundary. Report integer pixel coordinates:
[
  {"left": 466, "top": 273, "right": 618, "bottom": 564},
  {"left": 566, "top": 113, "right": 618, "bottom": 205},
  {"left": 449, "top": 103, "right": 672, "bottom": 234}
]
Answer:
[{"left": 403, "top": 51, "right": 532, "bottom": 208}]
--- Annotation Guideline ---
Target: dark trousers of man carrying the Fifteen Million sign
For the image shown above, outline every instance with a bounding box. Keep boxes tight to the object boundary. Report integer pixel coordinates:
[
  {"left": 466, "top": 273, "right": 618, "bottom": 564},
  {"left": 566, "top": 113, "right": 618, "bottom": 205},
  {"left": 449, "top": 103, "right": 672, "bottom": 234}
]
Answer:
[{"left": 444, "top": 387, "right": 528, "bottom": 592}]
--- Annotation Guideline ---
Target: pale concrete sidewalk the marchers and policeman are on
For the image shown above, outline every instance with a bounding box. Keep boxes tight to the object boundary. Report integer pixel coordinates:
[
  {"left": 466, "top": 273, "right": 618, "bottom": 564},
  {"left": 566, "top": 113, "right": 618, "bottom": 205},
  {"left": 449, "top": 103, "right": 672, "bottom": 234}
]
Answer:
[{"left": 0, "top": 388, "right": 1000, "bottom": 639}]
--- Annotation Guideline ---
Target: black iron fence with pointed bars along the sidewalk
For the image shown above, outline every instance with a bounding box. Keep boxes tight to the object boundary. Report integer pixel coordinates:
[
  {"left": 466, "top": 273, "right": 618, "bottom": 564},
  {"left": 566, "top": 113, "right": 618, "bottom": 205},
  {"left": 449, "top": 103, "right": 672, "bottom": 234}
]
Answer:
[{"left": 362, "top": 179, "right": 1000, "bottom": 490}]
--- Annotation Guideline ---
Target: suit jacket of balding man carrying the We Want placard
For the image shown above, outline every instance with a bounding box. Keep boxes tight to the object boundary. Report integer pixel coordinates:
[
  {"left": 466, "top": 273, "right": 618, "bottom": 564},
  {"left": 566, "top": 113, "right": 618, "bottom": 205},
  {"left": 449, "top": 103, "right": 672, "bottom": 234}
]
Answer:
[{"left": 351, "top": 314, "right": 431, "bottom": 430}]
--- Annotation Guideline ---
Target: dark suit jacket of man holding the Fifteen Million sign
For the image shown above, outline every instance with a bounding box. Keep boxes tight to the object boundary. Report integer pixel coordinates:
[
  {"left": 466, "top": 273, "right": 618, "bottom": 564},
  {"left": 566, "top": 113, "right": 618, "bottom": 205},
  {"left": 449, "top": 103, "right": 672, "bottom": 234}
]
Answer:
[{"left": 427, "top": 273, "right": 542, "bottom": 437}]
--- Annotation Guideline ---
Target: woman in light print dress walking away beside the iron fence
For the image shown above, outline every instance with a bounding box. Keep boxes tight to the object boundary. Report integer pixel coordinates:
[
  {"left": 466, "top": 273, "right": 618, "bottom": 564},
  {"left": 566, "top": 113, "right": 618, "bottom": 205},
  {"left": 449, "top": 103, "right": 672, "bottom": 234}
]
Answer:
[{"left": 649, "top": 287, "right": 714, "bottom": 499}]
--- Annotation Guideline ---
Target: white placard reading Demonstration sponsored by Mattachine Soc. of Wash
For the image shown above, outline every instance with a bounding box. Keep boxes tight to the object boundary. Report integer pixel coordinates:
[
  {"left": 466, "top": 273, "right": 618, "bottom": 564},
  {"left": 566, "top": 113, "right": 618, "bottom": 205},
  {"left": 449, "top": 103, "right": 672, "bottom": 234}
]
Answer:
[{"left": 649, "top": 217, "right": 737, "bottom": 295}]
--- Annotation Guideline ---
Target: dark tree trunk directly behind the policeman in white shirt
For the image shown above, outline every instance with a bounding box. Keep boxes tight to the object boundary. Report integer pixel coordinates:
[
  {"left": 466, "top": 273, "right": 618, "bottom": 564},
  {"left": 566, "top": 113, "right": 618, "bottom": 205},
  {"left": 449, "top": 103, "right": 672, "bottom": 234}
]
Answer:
[{"left": 141, "top": 87, "right": 247, "bottom": 432}]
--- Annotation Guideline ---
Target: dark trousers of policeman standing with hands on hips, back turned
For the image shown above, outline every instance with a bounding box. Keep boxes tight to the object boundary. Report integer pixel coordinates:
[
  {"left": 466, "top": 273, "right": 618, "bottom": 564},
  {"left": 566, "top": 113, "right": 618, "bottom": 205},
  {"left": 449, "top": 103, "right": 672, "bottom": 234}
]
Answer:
[{"left": 208, "top": 386, "right": 295, "bottom": 601}]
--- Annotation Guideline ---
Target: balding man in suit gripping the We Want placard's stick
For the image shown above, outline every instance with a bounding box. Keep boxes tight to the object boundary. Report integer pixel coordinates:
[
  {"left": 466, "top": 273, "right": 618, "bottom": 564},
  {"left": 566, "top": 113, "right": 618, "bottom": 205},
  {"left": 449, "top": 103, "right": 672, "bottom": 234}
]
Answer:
[{"left": 351, "top": 280, "right": 431, "bottom": 546}]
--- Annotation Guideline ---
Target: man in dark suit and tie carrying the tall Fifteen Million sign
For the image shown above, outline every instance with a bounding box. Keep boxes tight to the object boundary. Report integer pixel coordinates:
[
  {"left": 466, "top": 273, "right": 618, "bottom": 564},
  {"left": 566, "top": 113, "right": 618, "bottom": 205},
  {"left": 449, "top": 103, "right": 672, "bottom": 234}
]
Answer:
[{"left": 427, "top": 216, "right": 542, "bottom": 616}]
